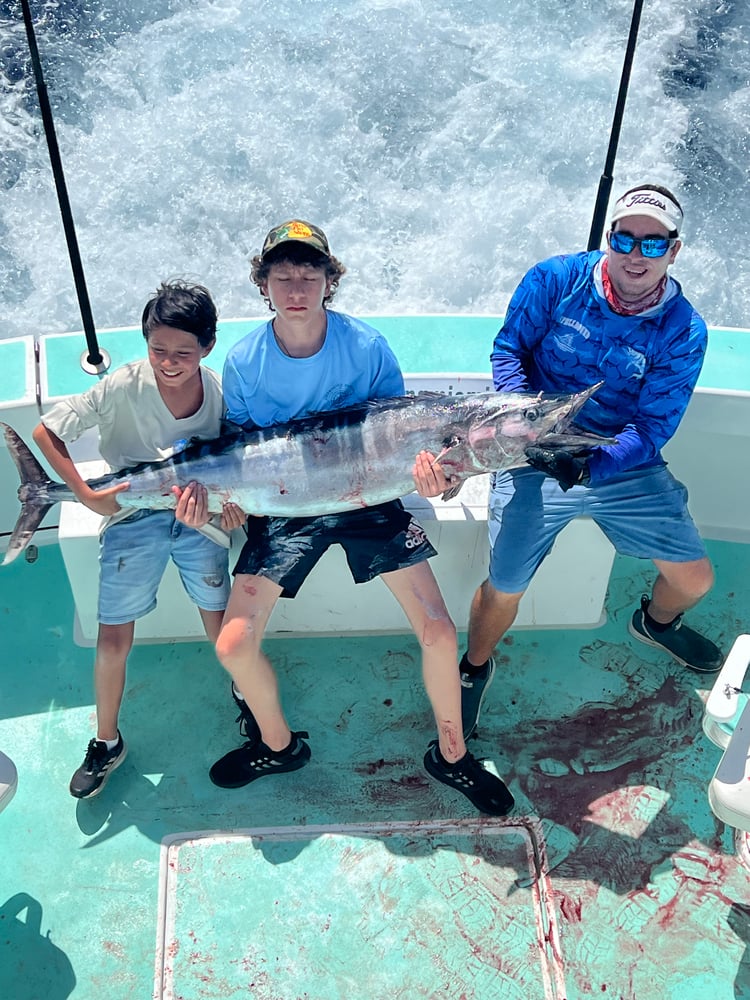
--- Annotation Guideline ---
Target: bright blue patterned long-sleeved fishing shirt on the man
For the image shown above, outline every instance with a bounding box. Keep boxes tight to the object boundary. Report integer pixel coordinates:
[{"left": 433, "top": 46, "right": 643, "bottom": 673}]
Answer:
[{"left": 490, "top": 251, "right": 708, "bottom": 483}]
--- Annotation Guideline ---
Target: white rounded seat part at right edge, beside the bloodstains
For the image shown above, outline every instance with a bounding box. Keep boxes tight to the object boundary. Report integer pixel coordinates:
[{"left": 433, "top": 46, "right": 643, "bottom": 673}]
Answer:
[{"left": 703, "top": 635, "right": 750, "bottom": 843}]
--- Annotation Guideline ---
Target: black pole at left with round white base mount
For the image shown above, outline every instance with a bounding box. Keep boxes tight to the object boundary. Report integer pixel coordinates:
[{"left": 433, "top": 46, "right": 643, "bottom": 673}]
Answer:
[{"left": 21, "top": 0, "right": 111, "bottom": 375}]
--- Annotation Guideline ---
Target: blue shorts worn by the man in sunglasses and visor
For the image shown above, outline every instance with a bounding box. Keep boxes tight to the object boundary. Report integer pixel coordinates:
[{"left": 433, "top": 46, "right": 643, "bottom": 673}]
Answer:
[{"left": 488, "top": 465, "right": 706, "bottom": 594}]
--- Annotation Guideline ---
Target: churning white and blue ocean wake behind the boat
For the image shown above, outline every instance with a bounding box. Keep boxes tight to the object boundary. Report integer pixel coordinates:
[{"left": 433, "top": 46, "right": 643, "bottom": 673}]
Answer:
[{"left": 0, "top": 0, "right": 750, "bottom": 338}]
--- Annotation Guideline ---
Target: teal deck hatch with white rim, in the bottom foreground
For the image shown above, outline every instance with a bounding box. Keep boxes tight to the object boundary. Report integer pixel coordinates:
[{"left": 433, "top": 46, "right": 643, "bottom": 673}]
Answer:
[{"left": 154, "top": 817, "right": 565, "bottom": 1000}]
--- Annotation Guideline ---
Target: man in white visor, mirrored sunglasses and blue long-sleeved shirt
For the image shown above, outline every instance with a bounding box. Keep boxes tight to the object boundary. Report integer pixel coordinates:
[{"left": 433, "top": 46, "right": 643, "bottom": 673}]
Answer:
[{"left": 420, "top": 185, "right": 722, "bottom": 735}]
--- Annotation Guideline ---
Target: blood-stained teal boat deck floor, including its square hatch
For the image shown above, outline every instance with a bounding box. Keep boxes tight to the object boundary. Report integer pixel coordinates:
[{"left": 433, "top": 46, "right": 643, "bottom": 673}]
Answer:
[{"left": 0, "top": 542, "right": 750, "bottom": 1000}]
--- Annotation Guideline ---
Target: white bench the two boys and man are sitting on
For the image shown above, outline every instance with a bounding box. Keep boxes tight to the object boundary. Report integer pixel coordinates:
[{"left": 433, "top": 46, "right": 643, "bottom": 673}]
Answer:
[{"left": 59, "top": 473, "right": 615, "bottom": 646}]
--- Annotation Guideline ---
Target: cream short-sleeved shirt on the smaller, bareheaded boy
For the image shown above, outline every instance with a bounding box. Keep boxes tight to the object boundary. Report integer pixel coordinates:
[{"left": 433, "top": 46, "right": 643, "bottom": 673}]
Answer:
[{"left": 41, "top": 358, "right": 224, "bottom": 540}]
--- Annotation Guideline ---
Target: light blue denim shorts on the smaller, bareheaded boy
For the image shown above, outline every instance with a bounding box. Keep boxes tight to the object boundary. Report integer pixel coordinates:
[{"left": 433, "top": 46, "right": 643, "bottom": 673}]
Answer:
[{"left": 98, "top": 510, "right": 230, "bottom": 625}]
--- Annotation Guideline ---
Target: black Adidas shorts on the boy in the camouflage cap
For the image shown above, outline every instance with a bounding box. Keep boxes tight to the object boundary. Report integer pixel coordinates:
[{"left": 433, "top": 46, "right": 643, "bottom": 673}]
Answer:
[{"left": 234, "top": 500, "right": 437, "bottom": 597}]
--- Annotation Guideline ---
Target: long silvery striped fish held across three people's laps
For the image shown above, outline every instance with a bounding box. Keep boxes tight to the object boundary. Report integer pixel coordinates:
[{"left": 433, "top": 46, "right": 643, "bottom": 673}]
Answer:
[{"left": 0, "top": 383, "right": 610, "bottom": 564}]
